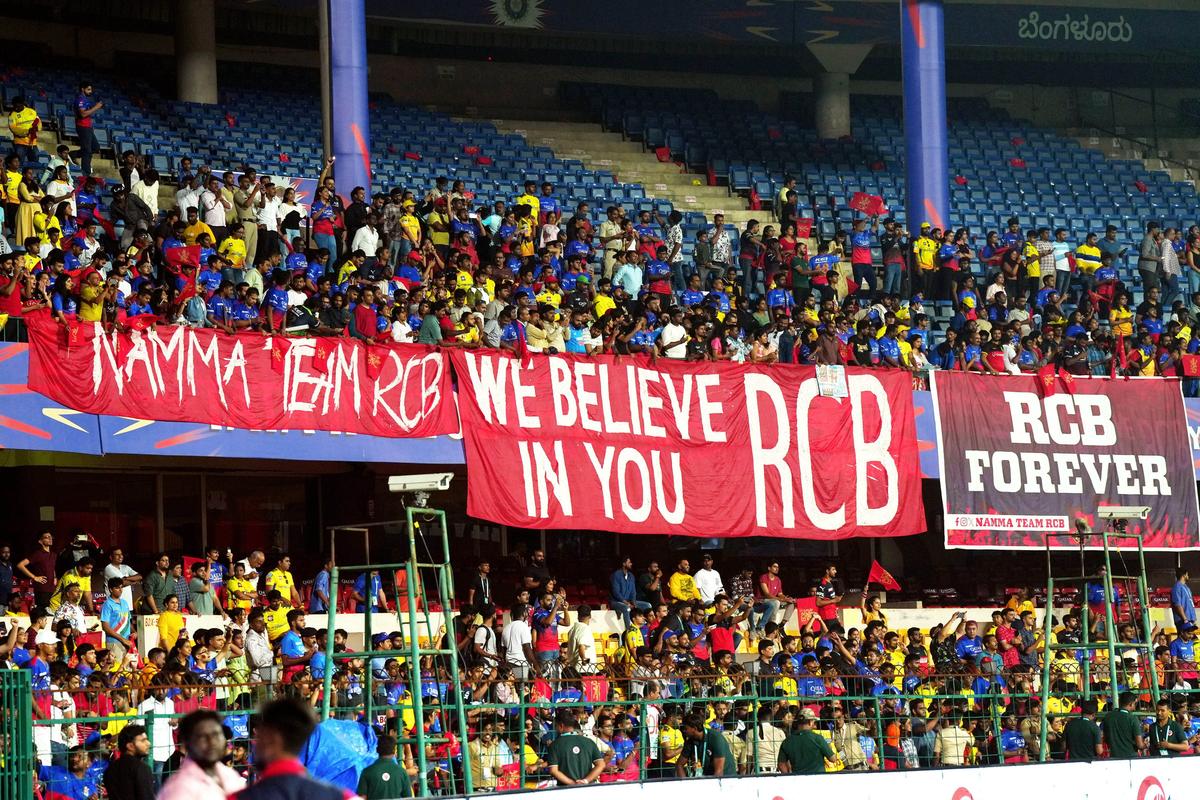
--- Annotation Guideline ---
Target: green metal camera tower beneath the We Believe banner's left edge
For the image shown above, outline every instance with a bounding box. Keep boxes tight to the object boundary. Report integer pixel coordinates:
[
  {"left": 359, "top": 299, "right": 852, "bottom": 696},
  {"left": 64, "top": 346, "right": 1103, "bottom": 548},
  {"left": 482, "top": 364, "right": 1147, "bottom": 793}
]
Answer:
[{"left": 321, "top": 506, "right": 474, "bottom": 800}]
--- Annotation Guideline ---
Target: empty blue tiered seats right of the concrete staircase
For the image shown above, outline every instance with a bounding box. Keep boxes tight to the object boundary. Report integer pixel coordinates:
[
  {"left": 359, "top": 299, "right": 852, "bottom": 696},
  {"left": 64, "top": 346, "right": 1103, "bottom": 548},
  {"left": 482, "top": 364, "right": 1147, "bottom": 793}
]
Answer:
[{"left": 563, "top": 84, "right": 1198, "bottom": 267}]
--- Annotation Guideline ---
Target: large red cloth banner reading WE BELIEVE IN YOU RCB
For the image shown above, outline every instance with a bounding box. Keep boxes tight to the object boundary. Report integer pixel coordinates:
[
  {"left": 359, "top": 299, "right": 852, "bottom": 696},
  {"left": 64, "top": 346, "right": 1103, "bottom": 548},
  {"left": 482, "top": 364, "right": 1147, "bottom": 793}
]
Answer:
[{"left": 450, "top": 351, "right": 925, "bottom": 539}]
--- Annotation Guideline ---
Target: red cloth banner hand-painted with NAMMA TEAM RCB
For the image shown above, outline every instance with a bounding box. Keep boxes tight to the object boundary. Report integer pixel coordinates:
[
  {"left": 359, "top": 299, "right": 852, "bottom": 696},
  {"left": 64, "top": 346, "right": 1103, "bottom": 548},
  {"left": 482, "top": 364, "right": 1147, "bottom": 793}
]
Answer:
[{"left": 26, "top": 313, "right": 458, "bottom": 437}]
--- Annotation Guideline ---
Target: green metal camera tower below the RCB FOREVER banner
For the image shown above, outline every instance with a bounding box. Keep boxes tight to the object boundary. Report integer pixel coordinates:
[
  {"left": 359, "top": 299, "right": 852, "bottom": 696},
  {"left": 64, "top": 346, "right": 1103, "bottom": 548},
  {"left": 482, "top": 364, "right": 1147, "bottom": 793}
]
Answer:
[{"left": 1039, "top": 530, "right": 1159, "bottom": 762}]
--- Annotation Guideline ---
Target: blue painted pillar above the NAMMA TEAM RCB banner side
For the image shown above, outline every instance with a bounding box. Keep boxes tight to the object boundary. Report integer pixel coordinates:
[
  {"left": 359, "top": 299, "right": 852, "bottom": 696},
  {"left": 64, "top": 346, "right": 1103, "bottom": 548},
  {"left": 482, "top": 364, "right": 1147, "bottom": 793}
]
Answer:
[{"left": 322, "top": 0, "right": 371, "bottom": 198}]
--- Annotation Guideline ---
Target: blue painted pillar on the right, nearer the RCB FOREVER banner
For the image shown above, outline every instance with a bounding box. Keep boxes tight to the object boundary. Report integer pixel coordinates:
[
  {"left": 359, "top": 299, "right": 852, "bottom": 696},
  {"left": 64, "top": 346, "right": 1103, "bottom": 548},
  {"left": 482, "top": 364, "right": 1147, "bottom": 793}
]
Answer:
[{"left": 900, "top": 0, "right": 952, "bottom": 234}]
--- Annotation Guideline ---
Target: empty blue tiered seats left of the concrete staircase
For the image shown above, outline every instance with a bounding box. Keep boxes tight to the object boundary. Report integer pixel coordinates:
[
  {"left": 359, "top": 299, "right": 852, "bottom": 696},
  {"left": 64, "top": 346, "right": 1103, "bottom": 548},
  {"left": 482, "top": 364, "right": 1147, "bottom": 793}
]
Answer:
[{"left": 2, "top": 71, "right": 671, "bottom": 213}]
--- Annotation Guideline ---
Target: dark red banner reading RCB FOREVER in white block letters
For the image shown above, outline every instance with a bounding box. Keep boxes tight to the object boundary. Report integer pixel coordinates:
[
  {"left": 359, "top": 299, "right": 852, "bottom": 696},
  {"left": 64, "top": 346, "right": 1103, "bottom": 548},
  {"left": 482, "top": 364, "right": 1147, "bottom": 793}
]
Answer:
[{"left": 934, "top": 372, "right": 1200, "bottom": 549}]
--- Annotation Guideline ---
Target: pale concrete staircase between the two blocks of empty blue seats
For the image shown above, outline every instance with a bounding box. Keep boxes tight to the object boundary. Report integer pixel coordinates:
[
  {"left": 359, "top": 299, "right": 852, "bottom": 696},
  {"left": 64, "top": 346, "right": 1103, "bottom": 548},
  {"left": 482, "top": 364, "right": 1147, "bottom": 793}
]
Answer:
[{"left": 492, "top": 120, "right": 758, "bottom": 230}]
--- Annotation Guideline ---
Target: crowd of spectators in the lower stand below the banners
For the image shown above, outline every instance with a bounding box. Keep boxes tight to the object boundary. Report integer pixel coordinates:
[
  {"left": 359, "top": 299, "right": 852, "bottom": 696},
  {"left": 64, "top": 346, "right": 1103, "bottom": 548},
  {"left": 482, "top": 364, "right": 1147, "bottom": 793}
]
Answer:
[{"left": 0, "top": 531, "right": 1200, "bottom": 798}]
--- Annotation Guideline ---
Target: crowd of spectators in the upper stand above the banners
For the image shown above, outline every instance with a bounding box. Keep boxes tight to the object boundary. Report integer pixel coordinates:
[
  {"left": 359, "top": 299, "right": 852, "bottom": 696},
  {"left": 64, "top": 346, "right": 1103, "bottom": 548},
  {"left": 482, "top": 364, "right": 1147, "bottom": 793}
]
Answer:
[{"left": 7, "top": 92, "right": 1200, "bottom": 395}]
